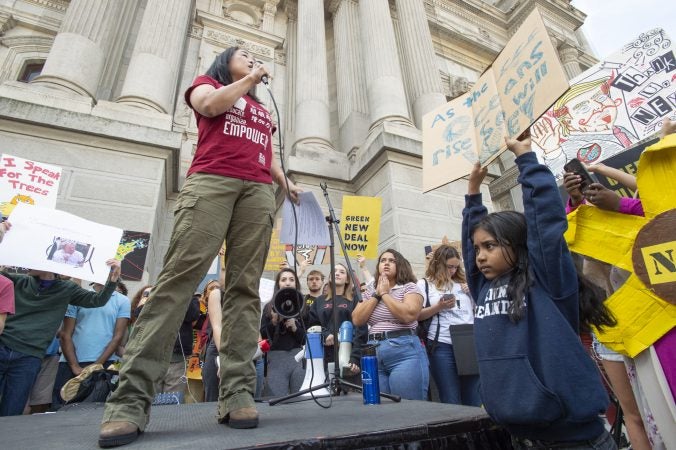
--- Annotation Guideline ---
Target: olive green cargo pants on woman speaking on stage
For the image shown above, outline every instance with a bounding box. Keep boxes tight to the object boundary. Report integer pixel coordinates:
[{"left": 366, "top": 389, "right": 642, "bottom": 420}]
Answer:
[{"left": 103, "top": 173, "right": 275, "bottom": 431}]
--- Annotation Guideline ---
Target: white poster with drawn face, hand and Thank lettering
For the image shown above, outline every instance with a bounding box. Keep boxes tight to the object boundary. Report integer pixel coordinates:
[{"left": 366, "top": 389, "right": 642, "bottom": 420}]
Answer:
[{"left": 531, "top": 28, "right": 676, "bottom": 179}]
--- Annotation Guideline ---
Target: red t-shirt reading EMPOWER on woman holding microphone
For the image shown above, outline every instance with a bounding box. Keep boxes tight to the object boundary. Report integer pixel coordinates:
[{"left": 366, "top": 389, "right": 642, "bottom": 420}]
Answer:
[{"left": 185, "top": 75, "right": 274, "bottom": 184}]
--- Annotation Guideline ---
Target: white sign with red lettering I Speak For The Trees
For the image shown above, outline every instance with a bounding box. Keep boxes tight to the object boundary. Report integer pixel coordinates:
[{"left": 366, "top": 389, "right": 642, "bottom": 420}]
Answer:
[{"left": 0, "top": 154, "right": 61, "bottom": 217}]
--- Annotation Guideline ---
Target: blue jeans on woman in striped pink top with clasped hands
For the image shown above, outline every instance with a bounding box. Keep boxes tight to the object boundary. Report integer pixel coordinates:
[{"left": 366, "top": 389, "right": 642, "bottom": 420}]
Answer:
[{"left": 369, "top": 335, "right": 430, "bottom": 400}]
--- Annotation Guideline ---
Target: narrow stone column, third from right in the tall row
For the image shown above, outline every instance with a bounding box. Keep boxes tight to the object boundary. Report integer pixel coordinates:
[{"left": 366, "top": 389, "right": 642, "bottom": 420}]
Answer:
[{"left": 329, "top": 0, "right": 369, "bottom": 152}]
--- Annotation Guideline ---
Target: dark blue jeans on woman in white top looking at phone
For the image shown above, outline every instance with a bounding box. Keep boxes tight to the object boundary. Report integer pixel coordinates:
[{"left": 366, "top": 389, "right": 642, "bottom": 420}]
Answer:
[{"left": 430, "top": 342, "right": 481, "bottom": 406}]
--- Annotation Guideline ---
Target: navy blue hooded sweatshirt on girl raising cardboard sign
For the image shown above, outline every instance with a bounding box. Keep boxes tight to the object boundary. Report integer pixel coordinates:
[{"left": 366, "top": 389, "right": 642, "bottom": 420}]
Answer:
[{"left": 462, "top": 153, "right": 608, "bottom": 441}]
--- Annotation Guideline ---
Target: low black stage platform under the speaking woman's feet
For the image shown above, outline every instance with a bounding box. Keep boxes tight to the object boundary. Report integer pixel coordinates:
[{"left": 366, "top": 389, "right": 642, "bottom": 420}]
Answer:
[{"left": 0, "top": 393, "right": 511, "bottom": 450}]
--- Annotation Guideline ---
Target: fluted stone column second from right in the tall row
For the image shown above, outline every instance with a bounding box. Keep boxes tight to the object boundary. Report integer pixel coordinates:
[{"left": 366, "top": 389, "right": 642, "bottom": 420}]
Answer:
[{"left": 359, "top": 0, "right": 411, "bottom": 126}]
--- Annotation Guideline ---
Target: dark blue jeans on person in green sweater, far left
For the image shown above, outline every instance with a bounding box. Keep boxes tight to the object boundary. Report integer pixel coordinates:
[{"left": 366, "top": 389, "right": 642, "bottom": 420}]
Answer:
[{"left": 0, "top": 344, "right": 42, "bottom": 417}]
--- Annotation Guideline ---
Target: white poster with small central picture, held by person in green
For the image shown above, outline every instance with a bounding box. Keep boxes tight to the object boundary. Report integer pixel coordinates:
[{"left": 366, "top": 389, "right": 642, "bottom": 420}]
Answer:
[{"left": 0, "top": 203, "right": 122, "bottom": 284}]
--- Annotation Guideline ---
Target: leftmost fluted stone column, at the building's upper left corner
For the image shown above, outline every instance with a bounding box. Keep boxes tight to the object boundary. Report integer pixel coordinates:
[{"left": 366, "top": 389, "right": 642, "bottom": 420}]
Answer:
[{"left": 34, "top": 0, "right": 125, "bottom": 98}]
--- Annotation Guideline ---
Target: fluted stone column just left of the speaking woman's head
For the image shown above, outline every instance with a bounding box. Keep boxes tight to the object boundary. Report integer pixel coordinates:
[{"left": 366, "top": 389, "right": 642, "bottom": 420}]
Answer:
[{"left": 117, "top": 0, "right": 191, "bottom": 114}]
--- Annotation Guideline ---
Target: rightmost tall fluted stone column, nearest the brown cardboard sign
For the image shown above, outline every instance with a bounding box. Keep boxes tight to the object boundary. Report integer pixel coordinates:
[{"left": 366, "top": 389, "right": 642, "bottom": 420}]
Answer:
[{"left": 396, "top": 0, "right": 446, "bottom": 127}]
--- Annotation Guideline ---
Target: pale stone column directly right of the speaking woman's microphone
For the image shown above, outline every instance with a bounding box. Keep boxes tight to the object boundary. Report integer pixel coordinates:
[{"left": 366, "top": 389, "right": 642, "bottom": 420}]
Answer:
[{"left": 295, "top": 0, "right": 331, "bottom": 149}]
